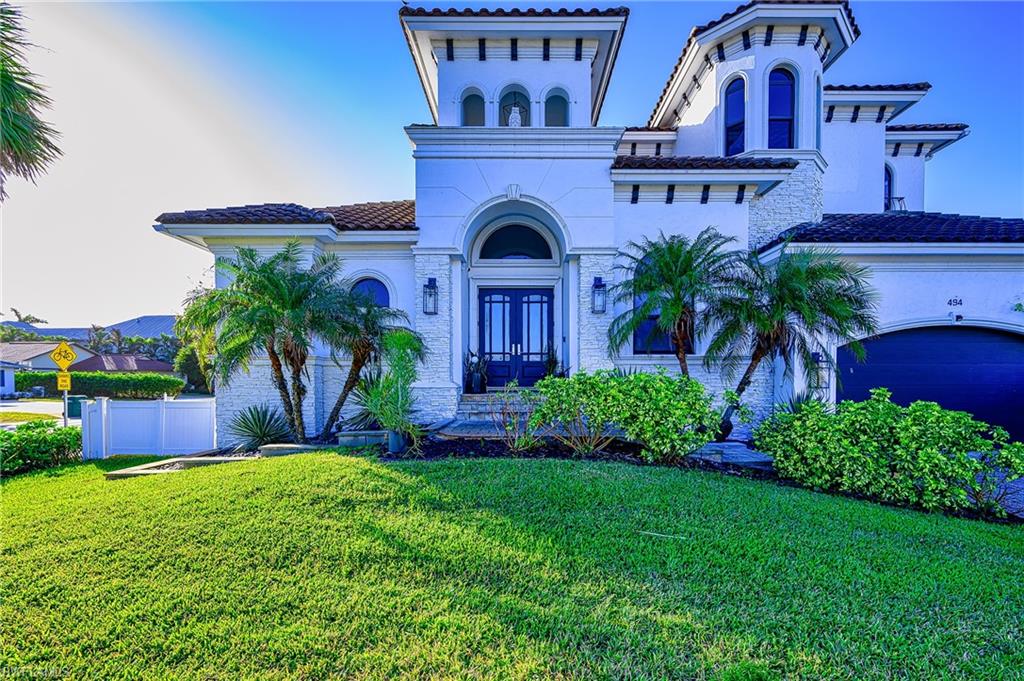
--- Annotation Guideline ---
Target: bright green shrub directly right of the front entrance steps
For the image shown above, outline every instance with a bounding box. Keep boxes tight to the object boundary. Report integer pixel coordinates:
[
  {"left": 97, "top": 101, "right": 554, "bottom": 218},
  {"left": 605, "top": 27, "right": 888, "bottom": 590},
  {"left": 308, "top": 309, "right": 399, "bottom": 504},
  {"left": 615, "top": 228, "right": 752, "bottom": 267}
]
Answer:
[{"left": 528, "top": 371, "right": 623, "bottom": 455}]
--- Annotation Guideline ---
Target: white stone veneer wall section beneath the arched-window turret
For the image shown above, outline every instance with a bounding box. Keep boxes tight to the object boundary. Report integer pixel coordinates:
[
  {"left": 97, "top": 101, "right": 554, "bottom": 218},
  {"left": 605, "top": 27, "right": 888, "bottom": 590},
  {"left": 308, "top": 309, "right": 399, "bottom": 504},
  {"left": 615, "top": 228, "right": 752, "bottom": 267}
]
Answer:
[{"left": 750, "top": 160, "right": 824, "bottom": 249}]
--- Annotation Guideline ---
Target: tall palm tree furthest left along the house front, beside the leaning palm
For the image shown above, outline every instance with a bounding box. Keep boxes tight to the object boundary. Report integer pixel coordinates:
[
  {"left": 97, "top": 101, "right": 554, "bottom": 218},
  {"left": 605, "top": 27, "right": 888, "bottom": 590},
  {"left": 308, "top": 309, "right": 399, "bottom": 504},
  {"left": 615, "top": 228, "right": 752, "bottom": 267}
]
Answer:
[{"left": 179, "top": 241, "right": 350, "bottom": 442}]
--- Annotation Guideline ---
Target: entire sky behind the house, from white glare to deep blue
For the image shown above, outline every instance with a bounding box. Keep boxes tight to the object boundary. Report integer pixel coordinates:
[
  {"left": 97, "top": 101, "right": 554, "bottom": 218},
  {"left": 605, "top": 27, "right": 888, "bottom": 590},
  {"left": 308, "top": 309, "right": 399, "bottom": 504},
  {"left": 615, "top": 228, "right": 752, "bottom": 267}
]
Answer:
[{"left": 0, "top": 0, "right": 1024, "bottom": 326}]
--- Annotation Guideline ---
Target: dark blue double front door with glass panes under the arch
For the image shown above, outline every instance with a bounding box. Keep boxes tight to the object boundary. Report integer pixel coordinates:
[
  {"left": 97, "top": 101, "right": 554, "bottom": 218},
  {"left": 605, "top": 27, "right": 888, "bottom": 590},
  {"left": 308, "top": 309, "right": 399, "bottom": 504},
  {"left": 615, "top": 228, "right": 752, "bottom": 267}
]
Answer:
[{"left": 479, "top": 289, "right": 555, "bottom": 387}]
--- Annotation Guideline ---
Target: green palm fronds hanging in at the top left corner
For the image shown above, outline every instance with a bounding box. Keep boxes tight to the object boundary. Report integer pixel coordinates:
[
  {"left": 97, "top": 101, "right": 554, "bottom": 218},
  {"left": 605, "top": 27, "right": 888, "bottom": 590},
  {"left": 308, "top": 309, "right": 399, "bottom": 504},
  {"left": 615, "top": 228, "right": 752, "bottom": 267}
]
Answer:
[{"left": 0, "top": 2, "right": 60, "bottom": 201}]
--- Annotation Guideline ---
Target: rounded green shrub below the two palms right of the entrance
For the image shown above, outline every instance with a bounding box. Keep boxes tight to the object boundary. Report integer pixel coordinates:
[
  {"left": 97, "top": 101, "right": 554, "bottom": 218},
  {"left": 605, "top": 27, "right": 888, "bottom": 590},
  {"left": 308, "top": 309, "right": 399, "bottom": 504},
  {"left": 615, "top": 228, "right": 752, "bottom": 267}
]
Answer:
[{"left": 612, "top": 370, "right": 720, "bottom": 464}]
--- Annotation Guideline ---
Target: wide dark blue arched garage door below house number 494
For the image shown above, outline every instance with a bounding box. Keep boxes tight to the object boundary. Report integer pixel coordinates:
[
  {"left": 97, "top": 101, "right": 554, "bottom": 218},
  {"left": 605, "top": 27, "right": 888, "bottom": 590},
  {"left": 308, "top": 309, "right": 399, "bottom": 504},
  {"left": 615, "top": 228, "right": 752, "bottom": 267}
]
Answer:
[{"left": 837, "top": 327, "right": 1024, "bottom": 439}]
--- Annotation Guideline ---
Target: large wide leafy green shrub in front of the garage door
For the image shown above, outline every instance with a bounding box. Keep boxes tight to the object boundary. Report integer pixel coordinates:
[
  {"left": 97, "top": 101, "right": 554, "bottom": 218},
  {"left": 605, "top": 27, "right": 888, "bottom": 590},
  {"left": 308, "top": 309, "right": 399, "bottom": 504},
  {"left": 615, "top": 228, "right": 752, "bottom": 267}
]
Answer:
[{"left": 755, "top": 388, "right": 1024, "bottom": 515}]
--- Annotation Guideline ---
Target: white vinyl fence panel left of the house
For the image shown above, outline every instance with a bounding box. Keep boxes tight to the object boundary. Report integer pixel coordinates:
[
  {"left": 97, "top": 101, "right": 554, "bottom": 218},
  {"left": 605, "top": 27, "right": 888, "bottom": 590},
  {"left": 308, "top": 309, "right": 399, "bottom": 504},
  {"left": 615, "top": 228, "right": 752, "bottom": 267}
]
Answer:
[{"left": 82, "top": 397, "right": 217, "bottom": 459}]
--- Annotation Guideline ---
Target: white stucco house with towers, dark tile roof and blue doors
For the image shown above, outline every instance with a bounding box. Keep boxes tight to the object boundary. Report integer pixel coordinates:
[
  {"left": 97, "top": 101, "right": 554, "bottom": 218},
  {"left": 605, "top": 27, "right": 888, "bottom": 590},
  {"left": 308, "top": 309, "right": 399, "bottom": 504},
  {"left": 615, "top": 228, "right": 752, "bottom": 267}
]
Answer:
[{"left": 156, "top": 0, "right": 1024, "bottom": 436}]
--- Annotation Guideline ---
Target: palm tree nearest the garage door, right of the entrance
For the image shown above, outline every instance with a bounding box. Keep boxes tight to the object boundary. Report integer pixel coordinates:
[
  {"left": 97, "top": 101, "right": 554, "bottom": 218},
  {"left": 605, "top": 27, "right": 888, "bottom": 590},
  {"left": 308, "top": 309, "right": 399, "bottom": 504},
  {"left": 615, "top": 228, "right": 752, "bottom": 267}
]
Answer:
[{"left": 705, "top": 249, "right": 878, "bottom": 439}]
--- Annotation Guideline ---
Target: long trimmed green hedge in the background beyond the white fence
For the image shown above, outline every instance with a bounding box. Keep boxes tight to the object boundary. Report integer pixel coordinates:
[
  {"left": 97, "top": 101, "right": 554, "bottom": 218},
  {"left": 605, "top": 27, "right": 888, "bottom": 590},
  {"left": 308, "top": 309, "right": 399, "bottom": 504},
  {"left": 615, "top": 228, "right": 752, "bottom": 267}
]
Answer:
[{"left": 14, "top": 372, "right": 185, "bottom": 399}]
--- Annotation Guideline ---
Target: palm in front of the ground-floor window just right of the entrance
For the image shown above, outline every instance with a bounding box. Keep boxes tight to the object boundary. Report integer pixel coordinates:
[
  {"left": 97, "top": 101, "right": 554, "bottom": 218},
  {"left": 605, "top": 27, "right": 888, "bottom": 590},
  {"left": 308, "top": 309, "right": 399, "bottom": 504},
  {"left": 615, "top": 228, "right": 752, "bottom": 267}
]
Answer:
[{"left": 608, "top": 227, "right": 737, "bottom": 376}]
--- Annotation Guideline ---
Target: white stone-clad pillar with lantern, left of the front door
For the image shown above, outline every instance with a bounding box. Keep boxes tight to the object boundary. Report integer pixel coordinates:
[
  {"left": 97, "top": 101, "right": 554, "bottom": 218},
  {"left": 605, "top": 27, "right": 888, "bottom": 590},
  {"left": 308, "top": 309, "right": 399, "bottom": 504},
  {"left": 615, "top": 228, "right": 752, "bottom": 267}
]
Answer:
[{"left": 414, "top": 249, "right": 461, "bottom": 423}]
